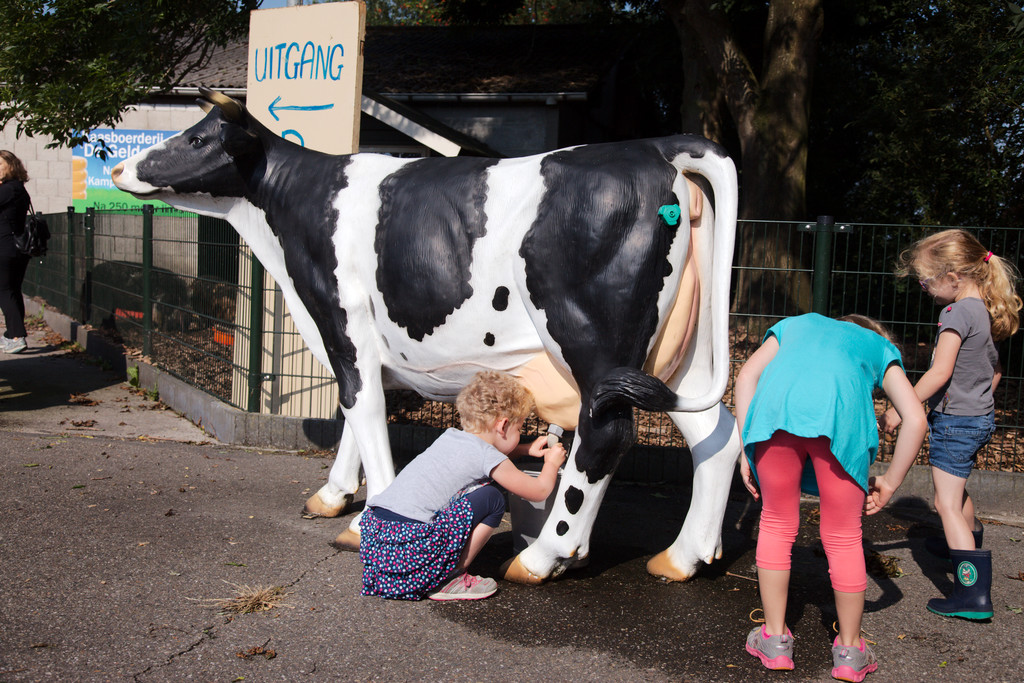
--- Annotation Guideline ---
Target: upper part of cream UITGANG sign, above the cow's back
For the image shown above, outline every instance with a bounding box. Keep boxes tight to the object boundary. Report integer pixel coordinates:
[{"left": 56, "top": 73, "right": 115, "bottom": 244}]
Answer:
[{"left": 246, "top": 0, "right": 367, "bottom": 154}]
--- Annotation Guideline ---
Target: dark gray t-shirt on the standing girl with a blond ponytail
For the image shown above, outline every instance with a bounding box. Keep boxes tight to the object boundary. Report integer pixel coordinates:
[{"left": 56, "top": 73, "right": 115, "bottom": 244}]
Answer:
[{"left": 929, "top": 297, "right": 999, "bottom": 415}]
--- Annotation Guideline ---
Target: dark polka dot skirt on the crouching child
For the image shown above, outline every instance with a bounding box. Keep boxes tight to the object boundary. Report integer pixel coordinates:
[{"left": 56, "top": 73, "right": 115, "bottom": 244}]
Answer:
[{"left": 359, "top": 498, "right": 473, "bottom": 600}]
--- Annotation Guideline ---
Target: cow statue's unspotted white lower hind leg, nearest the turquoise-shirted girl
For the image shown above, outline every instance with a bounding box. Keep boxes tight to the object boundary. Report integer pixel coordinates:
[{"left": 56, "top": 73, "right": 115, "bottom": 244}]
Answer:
[{"left": 647, "top": 403, "right": 740, "bottom": 581}]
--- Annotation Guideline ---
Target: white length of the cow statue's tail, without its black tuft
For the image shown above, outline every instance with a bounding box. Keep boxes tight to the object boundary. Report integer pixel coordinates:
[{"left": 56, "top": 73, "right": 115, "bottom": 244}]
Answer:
[{"left": 668, "top": 145, "right": 739, "bottom": 413}]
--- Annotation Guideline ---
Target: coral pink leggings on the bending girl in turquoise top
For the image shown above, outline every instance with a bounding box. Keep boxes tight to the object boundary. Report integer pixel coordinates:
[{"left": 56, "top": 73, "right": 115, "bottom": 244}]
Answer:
[{"left": 754, "top": 430, "right": 867, "bottom": 593}]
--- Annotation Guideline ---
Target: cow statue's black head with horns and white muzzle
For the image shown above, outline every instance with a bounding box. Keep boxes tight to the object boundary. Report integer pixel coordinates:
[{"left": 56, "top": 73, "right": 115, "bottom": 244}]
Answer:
[{"left": 111, "top": 88, "right": 266, "bottom": 206}]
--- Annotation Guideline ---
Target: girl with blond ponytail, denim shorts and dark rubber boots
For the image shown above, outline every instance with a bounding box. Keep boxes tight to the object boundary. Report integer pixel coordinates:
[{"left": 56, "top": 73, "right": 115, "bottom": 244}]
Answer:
[{"left": 882, "top": 229, "right": 1021, "bottom": 620}]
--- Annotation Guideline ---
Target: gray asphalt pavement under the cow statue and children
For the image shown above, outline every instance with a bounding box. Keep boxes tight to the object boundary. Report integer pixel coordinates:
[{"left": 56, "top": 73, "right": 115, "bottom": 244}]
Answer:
[{"left": 0, "top": 330, "right": 1024, "bottom": 683}]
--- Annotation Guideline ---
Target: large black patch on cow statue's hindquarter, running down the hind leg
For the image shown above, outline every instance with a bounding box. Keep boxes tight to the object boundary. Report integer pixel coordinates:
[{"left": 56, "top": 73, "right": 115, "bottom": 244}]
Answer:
[{"left": 519, "top": 136, "right": 688, "bottom": 481}]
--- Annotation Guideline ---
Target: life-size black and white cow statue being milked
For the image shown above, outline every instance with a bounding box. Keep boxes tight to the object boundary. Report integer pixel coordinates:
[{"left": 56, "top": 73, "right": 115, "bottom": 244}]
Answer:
[{"left": 113, "top": 89, "right": 739, "bottom": 584}]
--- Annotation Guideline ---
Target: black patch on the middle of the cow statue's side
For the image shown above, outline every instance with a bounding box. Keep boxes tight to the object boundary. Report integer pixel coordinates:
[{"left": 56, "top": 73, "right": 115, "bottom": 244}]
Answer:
[{"left": 374, "top": 157, "right": 498, "bottom": 341}]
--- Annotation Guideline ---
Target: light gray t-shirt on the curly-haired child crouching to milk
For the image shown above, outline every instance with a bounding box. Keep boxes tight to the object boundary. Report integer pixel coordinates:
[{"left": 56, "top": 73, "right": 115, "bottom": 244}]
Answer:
[{"left": 367, "top": 429, "right": 506, "bottom": 522}]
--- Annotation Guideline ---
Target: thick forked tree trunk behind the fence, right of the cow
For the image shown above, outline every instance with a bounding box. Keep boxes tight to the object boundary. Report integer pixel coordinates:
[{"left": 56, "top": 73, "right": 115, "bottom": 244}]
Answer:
[{"left": 662, "top": 0, "right": 823, "bottom": 315}]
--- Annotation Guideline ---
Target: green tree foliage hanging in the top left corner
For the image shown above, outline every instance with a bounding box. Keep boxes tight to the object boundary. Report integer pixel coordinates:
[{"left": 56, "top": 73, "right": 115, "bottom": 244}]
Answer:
[{"left": 0, "top": 0, "right": 259, "bottom": 146}]
